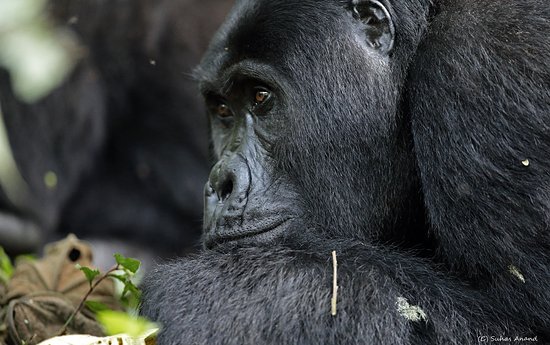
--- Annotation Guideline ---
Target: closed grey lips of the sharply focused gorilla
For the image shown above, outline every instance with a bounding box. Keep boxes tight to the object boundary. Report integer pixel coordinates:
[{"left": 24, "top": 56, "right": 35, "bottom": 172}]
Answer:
[{"left": 205, "top": 217, "right": 291, "bottom": 248}]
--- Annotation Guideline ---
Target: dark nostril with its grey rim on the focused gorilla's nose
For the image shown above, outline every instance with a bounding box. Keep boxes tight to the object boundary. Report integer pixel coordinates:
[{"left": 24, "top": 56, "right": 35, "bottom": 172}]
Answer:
[{"left": 209, "top": 157, "right": 249, "bottom": 204}]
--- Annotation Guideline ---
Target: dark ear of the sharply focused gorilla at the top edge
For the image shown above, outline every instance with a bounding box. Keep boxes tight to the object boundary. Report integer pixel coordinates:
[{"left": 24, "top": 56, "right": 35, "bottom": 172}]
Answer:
[{"left": 352, "top": 0, "right": 395, "bottom": 54}]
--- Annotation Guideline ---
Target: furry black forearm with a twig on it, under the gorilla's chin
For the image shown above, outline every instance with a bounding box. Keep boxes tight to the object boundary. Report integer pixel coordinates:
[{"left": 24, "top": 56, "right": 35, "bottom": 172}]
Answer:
[{"left": 141, "top": 242, "right": 529, "bottom": 344}]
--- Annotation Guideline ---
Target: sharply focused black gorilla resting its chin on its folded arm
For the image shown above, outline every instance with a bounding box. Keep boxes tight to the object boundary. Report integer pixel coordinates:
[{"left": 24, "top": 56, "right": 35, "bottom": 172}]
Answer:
[{"left": 141, "top": 0, "right": 550, "bottom": 345}]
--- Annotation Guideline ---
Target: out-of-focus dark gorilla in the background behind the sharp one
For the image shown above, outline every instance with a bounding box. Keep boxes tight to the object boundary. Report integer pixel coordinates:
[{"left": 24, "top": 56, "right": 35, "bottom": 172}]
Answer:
[{"left": 0, "top": 0, "right": 231, "bottom": 264}]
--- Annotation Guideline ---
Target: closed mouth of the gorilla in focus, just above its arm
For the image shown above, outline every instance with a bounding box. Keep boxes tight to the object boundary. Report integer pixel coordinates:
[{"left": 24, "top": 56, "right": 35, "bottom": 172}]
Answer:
[{"left": 205, "top": 217, "right": 290, "bottom": 248}]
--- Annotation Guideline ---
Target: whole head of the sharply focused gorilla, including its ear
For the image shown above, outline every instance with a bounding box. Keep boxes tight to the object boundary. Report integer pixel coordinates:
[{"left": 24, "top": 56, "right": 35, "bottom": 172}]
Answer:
[{"left": 202, "top": 0, "right": 420, "bottom": 247}]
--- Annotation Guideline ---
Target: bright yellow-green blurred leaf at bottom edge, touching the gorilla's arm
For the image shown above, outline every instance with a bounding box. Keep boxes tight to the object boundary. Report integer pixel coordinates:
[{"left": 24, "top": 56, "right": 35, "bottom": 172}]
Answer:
[{"left": 96, "top": 310, "right": 159, "bottom": 337}]
